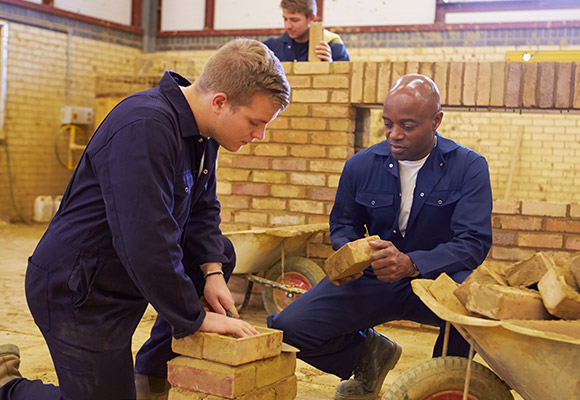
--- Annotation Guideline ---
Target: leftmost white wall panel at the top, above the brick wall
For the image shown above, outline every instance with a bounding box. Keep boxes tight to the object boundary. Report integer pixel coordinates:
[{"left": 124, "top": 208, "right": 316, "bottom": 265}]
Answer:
[{"left": 54, "top": 0, "right": 132, "bottom": 25}]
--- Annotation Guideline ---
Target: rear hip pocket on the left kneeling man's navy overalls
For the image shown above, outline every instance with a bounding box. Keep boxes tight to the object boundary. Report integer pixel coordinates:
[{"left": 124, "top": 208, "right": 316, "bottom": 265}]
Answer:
[{"left": 24, "top": 258, "right": 50, "bottom": 332}]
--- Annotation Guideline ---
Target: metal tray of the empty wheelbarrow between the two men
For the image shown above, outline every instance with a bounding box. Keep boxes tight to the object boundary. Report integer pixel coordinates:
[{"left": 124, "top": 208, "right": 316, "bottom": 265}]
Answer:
[{"left": 224, "top": 223, "right": 328, "bottom": 274}]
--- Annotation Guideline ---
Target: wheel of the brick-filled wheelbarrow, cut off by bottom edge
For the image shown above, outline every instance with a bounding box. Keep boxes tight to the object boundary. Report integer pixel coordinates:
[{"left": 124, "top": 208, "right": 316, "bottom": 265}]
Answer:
[{"left": 382, "top": 357, "right": 513, "bottom": 400}]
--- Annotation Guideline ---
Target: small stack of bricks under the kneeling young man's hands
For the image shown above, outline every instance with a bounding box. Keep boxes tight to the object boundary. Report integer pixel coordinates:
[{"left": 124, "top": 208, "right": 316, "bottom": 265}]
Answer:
[{"left": 167, "top": 328, "right": 297, "bottom": 400}]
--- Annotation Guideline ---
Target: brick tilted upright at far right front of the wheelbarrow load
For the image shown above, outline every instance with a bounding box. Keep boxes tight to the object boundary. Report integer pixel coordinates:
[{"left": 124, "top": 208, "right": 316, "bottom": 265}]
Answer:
[{"left": 538, "top": 268, "right": 580, "bottom": 319}]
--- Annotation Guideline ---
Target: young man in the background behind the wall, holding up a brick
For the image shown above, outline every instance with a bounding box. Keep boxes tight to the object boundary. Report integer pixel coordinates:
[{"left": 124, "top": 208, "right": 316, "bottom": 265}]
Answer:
[{"left": 264, "top": 0, "right": 350, "bottom": 62}]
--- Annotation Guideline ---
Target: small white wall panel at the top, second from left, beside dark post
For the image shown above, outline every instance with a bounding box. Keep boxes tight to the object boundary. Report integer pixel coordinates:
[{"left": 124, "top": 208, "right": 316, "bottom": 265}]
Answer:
[{"left": 161, "top": 0, "right": 205, "bottom": 31}]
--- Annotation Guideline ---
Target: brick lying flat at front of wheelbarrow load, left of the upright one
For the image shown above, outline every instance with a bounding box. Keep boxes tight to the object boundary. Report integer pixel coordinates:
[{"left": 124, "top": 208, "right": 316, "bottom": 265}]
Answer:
[{"left": 465, "top": 282, "right": 550, "bottom": 320}]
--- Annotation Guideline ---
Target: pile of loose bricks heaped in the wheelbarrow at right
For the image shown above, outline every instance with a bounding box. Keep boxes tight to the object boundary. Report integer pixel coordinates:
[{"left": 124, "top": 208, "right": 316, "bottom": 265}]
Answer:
[{"left": 430, "top": 252, "right": 580, "bottom": 320}]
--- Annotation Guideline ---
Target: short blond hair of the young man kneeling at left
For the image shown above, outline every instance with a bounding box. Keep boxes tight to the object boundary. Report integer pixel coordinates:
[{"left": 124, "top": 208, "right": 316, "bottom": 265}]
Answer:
[{"left": 195, "top": 38, "right": 290, "bottom": 110}]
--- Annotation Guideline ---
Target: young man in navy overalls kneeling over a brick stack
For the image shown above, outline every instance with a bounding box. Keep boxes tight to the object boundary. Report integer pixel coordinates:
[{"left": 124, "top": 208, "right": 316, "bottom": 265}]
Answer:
[{"left": 0, "top": 39, "right": 290, "bottom": 400}]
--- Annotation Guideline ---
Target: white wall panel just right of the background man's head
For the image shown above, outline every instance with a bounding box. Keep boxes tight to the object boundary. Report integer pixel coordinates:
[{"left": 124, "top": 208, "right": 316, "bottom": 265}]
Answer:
[{"left": 322, "top": 0, "right": 436, "bottom": 26}]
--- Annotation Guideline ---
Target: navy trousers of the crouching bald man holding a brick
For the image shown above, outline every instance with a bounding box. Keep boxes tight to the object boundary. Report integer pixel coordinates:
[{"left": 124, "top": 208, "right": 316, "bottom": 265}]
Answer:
[{"left": 268, "top": 271, "right": 438, "bottom": 379}]
